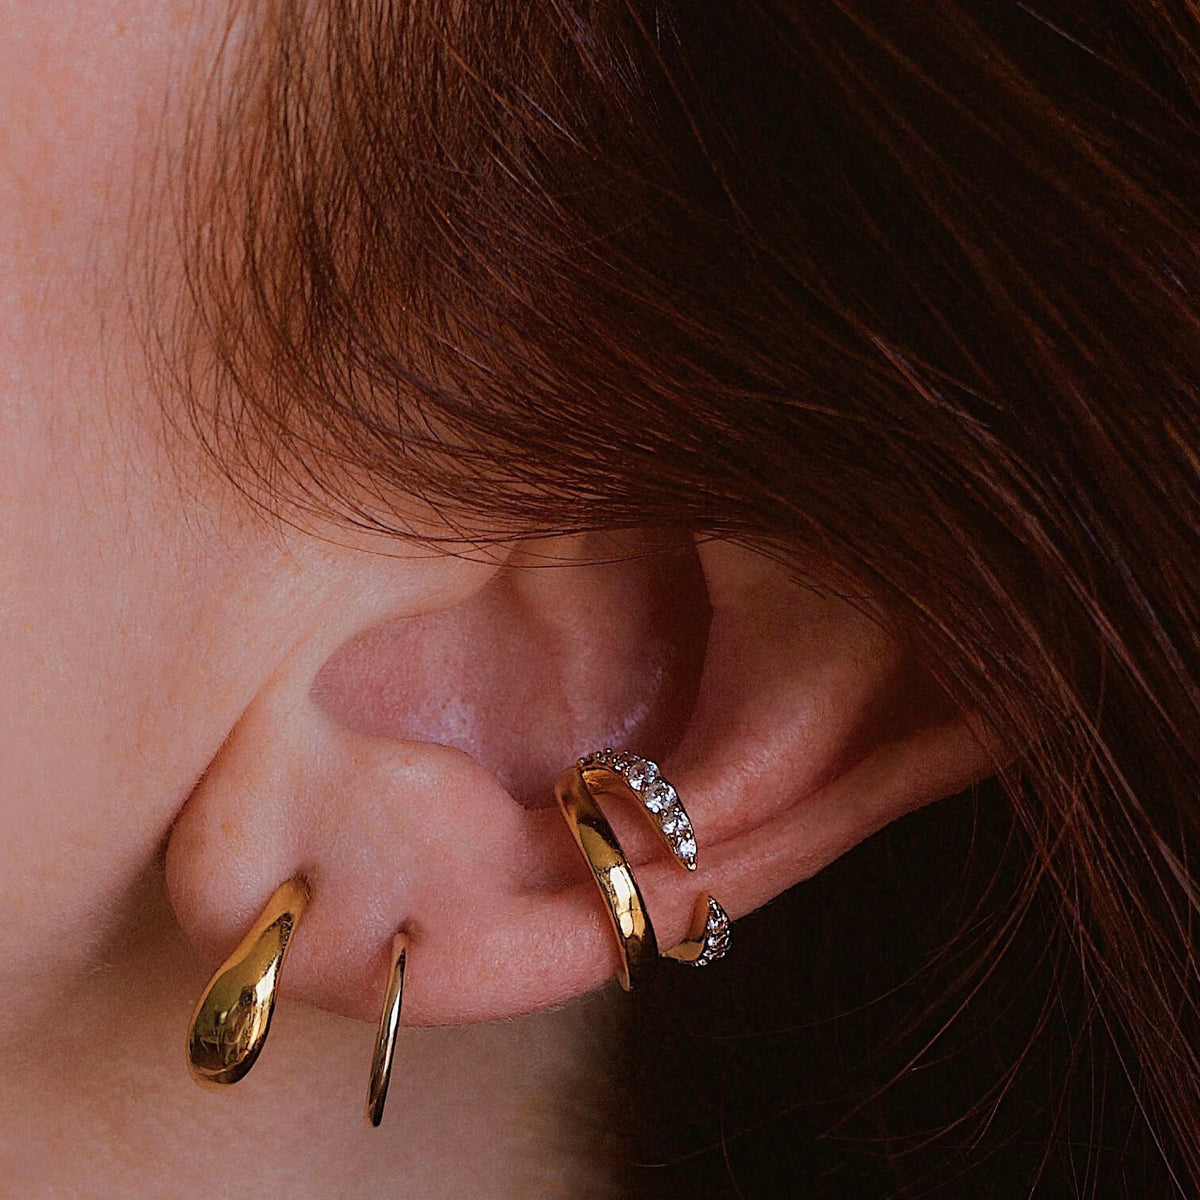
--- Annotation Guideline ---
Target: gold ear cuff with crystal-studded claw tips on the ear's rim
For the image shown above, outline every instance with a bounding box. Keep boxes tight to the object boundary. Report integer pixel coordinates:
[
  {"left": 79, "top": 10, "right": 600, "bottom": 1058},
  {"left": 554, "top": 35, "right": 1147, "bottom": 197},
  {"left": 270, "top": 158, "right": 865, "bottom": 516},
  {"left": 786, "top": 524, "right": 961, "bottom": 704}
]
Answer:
[{"left": 554, "top": 749, "right": 730, "bottom": 991}]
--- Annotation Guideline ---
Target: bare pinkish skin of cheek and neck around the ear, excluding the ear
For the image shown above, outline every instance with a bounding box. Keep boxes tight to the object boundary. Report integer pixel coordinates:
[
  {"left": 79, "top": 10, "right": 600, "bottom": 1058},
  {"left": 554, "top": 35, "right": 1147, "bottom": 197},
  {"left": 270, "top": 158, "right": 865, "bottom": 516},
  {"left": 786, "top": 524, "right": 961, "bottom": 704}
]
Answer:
[{"left": 0, "top": 7, "right": 638, "bottom": 1196}]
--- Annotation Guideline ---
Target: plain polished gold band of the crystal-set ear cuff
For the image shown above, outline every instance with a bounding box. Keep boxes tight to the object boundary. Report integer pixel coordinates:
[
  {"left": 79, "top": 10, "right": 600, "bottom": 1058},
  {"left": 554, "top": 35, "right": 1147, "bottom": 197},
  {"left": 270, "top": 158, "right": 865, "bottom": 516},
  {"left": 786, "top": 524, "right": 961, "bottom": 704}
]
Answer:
[{"left": 554, "top": 766, "right": 659, "bottom": 991}]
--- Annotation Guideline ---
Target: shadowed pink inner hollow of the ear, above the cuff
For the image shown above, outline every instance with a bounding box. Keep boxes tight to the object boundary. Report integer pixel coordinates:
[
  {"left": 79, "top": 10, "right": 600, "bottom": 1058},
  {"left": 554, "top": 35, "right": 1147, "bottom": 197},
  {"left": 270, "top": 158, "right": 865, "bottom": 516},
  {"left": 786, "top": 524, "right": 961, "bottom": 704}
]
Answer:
[{"left": 312, "top": 530, "right": 712, "bottom": 809}]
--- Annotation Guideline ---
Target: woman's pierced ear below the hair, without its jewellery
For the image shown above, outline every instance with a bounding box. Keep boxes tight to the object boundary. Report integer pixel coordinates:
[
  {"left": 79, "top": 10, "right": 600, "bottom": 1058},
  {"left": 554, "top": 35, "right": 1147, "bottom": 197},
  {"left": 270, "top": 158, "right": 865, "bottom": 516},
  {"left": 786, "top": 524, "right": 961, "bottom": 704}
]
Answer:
[{"left": 167, "top": 535, "right": 996, "bottom": 1024}]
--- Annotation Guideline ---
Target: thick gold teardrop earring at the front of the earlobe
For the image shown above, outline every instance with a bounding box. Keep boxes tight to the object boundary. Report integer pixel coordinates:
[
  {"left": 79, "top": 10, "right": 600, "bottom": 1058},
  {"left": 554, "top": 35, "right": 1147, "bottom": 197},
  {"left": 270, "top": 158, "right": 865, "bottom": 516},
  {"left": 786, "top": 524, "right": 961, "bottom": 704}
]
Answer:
[{"left": 187, "top": 880, "right": 308, "bottom": 1088}]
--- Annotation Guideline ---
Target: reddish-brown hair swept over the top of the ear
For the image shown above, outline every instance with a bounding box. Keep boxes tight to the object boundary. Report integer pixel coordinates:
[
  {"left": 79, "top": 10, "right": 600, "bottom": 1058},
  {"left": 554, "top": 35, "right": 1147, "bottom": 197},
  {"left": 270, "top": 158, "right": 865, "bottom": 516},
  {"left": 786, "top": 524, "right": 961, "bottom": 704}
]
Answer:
[{"left": 172, "top": 0, "right": 1200, "bottom": 1190}]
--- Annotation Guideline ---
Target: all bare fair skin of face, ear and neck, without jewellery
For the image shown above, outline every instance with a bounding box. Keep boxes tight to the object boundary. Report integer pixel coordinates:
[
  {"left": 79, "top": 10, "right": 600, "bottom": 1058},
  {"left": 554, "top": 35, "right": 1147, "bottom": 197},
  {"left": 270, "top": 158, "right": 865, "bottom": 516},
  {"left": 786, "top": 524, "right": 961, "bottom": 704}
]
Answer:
[{"left": 0, "top": 0, "right": 994, "bottom": 1196}]
